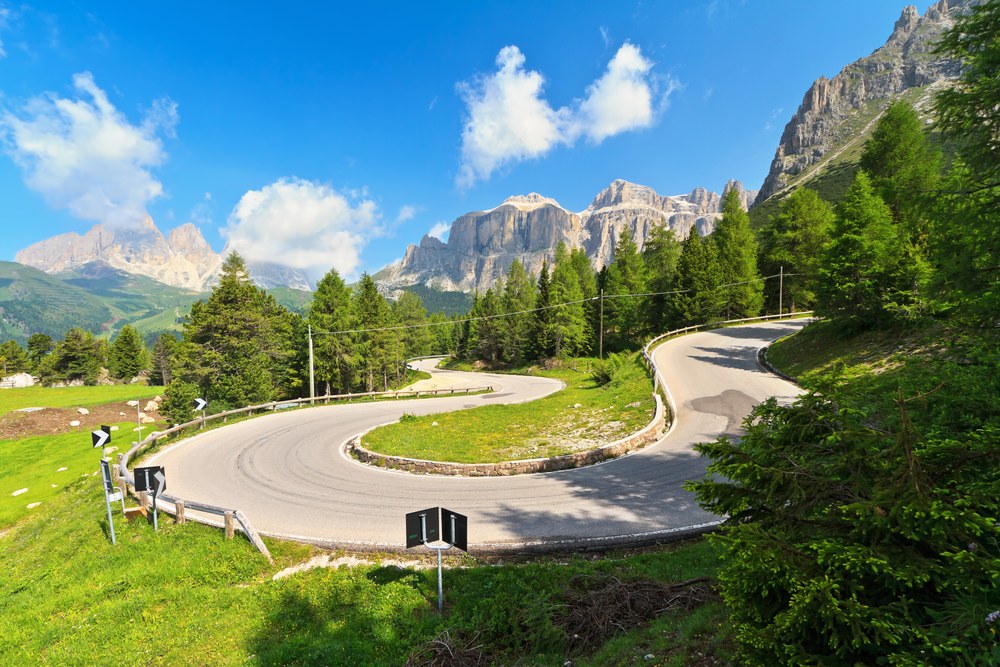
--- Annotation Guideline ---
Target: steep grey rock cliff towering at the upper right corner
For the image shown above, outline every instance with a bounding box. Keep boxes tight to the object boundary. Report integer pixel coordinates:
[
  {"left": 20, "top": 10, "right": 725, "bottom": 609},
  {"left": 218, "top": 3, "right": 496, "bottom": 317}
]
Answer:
[{"left": 757, "top": 0, "right": 979, "bottom": 201}]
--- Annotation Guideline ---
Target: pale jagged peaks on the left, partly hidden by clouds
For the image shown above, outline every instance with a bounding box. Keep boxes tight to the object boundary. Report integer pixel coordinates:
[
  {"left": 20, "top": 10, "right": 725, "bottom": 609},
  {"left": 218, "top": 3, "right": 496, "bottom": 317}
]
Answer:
[{"left": 14, "top": 216, "right": 311, "bottom": 292}]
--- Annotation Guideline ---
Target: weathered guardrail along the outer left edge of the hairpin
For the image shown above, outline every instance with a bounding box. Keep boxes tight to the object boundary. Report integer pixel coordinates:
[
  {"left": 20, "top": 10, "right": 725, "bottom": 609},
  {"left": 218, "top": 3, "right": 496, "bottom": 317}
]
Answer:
[{"left": 118, "top": 386, "right": 493, "bottom": 562}]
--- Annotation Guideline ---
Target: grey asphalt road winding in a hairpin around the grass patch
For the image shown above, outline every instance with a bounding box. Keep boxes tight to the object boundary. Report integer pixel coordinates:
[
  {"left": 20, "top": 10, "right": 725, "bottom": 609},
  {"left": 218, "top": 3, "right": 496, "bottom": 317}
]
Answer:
[{"left": 148, "top": 320, "right": 805, "bottom": 553}]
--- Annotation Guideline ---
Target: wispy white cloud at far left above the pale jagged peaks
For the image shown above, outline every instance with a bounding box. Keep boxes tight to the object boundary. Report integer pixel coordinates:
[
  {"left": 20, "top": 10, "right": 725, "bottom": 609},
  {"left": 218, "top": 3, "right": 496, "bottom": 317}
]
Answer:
[{"left": 0, "top": 72, "right": 178, "bottom": 227}]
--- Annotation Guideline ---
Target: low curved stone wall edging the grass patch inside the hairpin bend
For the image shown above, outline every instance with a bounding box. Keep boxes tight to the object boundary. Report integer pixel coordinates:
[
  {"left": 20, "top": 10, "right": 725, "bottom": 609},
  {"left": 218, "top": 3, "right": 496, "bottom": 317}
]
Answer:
[{"left": 347, "top": 394, "right": 666, "bottom": 477}]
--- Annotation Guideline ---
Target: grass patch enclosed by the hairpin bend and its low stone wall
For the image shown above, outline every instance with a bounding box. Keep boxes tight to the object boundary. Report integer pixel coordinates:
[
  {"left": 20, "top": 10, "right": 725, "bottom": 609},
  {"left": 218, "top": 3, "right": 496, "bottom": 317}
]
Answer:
[{"left": 362, "top": 355, "right": 656, "bottom": 463}]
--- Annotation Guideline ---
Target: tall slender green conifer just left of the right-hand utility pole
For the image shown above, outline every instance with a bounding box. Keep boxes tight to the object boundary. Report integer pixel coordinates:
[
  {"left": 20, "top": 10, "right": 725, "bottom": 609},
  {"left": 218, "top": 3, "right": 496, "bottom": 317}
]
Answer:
[{"left": 711, "top": 188, "right": 764, "bottom": 319}]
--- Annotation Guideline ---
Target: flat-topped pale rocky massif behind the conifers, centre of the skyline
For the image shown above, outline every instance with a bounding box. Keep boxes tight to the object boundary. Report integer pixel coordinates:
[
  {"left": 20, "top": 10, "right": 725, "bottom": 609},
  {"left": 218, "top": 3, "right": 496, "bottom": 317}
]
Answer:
[{"left": 375, "top": 180, "right": 756, "bottom": 292}]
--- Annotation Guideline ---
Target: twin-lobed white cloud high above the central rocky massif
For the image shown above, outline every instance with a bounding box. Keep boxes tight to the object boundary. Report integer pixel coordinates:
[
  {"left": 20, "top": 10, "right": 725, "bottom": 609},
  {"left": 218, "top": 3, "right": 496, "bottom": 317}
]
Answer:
[{"left": 456, "top": 42, "right": 674, "bottom": 187}]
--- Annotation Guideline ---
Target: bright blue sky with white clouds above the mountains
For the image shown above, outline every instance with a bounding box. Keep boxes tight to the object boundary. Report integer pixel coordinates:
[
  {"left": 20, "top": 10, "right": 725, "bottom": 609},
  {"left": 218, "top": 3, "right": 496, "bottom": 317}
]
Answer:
[{"left": 0, "top": 0, "right": 930, "bottom": 279}]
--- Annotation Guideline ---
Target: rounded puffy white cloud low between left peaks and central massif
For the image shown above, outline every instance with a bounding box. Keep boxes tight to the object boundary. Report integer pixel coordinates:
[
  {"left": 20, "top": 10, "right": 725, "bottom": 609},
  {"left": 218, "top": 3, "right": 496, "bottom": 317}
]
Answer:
[{"left": 222, "top": 178, "right": 382, "bottom": 280}]
